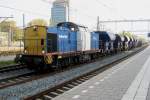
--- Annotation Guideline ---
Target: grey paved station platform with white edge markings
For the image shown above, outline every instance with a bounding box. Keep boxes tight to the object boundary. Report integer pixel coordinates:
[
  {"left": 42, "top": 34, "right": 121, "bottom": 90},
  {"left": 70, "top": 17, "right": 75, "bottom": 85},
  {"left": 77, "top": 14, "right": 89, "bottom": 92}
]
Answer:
[{"left": 53, "top": 46, "right": 150, "bottom": 100}]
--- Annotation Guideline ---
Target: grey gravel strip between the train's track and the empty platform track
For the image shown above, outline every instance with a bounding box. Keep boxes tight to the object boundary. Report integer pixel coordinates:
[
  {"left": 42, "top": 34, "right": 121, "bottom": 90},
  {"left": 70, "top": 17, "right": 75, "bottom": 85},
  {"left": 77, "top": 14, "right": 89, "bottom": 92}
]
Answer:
[{"left": 0, "top": 47, "right": 144, "bottom": 100}]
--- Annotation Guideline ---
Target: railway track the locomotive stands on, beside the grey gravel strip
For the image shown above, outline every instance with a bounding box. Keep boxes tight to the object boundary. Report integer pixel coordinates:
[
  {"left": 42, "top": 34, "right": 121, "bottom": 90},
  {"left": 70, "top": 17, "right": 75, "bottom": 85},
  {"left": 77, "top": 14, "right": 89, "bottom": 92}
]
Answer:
[{"left": 0, "top": 61, "right": 99, "bottom": 89}]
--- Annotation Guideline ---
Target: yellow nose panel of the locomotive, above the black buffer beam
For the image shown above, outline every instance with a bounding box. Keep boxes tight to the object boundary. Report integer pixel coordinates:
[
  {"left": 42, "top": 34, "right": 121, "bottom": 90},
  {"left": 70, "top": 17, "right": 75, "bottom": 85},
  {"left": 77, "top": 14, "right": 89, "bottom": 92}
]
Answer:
[{"left": 24, "top": 26, "right": 47, "bottom": 55}]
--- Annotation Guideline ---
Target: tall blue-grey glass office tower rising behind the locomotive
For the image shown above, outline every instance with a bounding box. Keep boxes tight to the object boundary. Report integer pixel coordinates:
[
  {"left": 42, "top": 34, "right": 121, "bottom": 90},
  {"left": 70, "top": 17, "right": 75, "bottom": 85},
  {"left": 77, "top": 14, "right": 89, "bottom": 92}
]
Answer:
[{"left": 51, "top": 0, "right": 69, "bottom": 26}]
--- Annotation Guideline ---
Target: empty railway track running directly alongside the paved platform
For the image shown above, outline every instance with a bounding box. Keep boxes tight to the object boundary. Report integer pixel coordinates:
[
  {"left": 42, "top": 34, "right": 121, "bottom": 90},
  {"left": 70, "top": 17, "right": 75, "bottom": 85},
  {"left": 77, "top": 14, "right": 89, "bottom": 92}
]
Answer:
[{"left": 24, "top": 47, "right": 146, "bottom": 100}]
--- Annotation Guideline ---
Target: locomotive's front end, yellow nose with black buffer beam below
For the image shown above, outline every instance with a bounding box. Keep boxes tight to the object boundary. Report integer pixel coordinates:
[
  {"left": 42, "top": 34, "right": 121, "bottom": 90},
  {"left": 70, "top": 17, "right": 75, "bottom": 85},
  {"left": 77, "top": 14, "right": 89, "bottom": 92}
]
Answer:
[{"left": 16, "top": 26, "right": 52, "bottom": 69}]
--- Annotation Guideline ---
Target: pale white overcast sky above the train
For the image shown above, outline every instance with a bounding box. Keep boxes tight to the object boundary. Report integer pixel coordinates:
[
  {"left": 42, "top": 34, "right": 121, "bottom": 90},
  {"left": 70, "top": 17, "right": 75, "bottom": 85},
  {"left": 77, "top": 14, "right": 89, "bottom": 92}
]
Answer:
[{"left": 0, "top": 0, "right": 150, "bottom": 33}]
